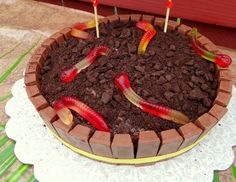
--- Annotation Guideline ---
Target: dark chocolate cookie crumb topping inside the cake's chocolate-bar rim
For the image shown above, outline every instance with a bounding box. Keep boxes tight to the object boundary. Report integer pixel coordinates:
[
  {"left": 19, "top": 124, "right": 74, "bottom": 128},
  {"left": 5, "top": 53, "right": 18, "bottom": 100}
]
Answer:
[{"left": 40, "top": 21, "right": 218, "bottom": 135}]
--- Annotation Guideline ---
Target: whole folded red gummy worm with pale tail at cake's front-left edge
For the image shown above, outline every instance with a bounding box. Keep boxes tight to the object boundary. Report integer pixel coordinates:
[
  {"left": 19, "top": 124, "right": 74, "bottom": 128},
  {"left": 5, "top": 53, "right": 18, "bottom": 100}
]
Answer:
[{"left": 53, "top": 96, "right": 110, "bottom": 132}]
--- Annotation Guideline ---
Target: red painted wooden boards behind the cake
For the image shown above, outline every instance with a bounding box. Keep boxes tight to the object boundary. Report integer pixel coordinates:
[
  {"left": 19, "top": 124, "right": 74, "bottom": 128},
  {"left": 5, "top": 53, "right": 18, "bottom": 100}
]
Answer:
[{"left": 83, "top": 0, "right": 236, "bottom": 28}]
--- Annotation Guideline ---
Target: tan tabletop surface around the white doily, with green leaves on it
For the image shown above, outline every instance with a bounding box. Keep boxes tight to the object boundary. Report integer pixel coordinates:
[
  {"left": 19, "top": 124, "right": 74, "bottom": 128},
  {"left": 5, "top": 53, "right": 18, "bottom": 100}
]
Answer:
[{"left": 0, "top": 0, "right": 236, "bottom": 182}]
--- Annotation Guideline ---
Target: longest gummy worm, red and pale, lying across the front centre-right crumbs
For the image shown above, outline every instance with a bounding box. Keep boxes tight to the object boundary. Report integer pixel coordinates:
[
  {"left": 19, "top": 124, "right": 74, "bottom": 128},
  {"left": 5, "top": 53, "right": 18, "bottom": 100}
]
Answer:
[{"left": 115, "top": 73, "right": 190, "bottom": 124}]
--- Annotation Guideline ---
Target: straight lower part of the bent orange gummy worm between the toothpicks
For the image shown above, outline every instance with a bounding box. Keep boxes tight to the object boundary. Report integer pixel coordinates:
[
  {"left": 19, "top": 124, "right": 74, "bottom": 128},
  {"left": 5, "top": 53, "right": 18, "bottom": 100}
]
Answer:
[{"left": 138, "top": 30, "right": 156, "bottom": 54}]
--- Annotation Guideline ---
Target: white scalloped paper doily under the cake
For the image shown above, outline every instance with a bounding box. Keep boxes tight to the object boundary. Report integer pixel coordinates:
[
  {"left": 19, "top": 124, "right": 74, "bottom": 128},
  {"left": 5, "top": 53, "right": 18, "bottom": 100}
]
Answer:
[{"left": 6, "top": 79, "right": 236, "bottom": 182}]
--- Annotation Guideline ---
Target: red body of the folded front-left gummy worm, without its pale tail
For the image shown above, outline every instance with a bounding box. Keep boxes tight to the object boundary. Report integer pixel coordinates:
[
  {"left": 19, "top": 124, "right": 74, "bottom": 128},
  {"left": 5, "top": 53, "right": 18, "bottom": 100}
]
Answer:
[{"left": 54, "top": 96, "right": 110, "bottom": 132}]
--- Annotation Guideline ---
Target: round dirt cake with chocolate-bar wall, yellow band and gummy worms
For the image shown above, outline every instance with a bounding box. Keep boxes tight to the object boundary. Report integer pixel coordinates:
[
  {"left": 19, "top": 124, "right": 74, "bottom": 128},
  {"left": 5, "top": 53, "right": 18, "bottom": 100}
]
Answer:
[{"left": 25, "top": 15, "right": 232, "bottom": 164}]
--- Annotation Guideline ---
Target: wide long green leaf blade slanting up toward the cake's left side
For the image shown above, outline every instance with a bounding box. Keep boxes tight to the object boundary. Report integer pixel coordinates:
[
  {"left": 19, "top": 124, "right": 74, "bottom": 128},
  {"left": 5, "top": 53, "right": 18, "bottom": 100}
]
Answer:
[{"left": 0, "top": 36, "right": 41, "bottom": 83}]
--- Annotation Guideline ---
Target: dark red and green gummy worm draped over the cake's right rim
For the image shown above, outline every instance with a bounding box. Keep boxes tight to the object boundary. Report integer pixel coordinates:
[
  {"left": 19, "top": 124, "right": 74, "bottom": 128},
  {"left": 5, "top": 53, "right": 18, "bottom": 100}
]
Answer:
[{"left": 191, "top": 28, "right": 232, "bottom": 67}]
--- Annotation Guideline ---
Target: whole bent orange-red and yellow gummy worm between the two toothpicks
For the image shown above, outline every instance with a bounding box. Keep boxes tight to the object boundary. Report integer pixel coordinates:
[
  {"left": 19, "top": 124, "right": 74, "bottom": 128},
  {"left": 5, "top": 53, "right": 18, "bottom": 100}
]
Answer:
[{"left": 136, "top": 21, "right": 156, "bottom": 54}]
